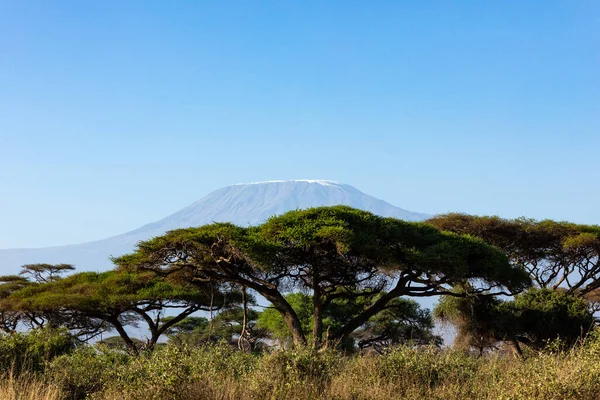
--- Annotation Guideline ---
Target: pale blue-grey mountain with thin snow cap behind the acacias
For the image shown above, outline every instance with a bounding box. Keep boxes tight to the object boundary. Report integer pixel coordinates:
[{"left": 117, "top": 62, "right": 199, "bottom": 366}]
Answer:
[{"left": 0, "top": 180, "right": 429, "bottom": 274}]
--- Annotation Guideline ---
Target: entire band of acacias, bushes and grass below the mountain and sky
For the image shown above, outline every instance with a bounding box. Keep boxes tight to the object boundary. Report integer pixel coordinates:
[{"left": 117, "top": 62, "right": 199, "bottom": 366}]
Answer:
[{"left": 0, "top": 206, "right": 600, "bottom": 400}]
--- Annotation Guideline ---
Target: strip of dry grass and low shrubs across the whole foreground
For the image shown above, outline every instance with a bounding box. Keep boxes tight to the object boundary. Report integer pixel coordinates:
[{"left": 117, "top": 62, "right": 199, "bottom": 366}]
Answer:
[{"left": 0, "top": 335, "right": 600, "bottom": 400}]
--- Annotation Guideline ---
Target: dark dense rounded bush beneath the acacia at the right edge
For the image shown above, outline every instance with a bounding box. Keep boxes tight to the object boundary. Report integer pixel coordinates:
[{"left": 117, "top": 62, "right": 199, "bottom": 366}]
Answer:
[{"left": 434, "top": 288, "right": 594, "bottom": 356}]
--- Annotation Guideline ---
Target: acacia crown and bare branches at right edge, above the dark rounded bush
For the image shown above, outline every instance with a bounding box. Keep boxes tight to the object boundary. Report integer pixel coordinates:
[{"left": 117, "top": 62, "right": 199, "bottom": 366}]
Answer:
[{"left": 427, "top": 214, "right": 600, "bottom": 296}]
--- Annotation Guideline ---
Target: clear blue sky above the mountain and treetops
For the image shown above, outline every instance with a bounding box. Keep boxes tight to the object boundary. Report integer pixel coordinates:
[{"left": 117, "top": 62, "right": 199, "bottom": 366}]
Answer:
[{"left": 0, "top": 0, "right": 600, "bottom": 248}]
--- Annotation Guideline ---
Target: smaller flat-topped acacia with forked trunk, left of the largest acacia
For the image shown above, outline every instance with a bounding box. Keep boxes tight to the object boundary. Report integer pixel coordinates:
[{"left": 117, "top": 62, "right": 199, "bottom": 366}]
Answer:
[{"left": 0, "top": 271, "right": 234, "bottom": 353}]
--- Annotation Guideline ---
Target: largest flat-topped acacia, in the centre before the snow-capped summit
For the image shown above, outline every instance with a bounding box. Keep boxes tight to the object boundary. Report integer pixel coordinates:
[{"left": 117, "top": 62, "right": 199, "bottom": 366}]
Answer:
[{"left": 114, "top": 206, "right": 530, "bottom": 347}]
